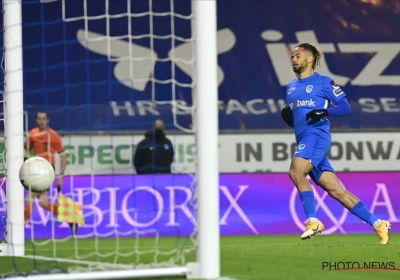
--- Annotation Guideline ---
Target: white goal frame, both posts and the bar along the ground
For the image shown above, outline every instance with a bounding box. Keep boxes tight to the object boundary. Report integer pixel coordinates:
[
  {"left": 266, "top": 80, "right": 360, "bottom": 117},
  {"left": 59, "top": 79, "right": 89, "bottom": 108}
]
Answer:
[{"left": 0, "top": 0, "right": 220, "bottom": 280}]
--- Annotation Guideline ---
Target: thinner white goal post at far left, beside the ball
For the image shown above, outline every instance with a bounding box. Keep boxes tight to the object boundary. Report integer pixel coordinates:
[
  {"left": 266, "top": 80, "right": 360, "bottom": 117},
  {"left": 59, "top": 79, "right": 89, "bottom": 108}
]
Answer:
[{"left": 3, "top": 0, "right": 25, "bottom": 257}]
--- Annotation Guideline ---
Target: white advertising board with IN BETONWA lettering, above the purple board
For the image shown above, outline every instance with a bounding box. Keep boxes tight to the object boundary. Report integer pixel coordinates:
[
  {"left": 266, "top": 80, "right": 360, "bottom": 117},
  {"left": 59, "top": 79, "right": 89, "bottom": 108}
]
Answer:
[{"left": 53, "top": 133, "right": 400, "bottom": 175}]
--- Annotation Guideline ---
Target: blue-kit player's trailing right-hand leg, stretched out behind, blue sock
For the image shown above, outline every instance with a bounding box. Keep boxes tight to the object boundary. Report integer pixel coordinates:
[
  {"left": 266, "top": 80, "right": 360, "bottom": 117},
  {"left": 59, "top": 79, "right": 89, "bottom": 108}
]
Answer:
[{"left": 318, "top": 170, "right": 392, "bottom": 244}]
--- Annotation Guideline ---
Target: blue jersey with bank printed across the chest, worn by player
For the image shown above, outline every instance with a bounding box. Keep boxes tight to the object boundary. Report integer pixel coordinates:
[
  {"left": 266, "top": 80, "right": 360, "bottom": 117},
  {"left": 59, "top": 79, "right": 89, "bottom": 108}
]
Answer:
[{"left": 286, "top": 72, "right": 346, "bottom": 139}]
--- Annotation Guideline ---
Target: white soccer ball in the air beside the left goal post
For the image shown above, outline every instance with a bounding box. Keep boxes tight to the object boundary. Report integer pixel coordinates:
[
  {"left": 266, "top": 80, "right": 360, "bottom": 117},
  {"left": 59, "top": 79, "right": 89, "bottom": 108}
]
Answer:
[{"left": 19, "top": 157, "right": 55, "bottom": 193}]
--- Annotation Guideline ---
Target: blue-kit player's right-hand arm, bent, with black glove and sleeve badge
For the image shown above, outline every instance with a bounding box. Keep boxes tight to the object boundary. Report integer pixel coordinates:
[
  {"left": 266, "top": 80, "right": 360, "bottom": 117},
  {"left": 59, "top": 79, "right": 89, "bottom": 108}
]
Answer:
[{"left": 306, "top": 80, "right": 351, "bottom": 120}]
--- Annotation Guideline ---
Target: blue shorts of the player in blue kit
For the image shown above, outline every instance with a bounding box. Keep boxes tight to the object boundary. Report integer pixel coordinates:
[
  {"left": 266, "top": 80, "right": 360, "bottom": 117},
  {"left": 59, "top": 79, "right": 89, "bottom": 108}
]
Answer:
[{"left": 293, "top": 133, "right": 335, "bottom": 185}]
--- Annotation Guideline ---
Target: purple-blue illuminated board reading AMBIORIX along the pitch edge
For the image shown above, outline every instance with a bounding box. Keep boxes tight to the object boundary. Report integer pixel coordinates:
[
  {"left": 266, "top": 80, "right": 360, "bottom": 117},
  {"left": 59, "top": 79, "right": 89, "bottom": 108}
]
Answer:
[{"left": 0, "top": 172, "right": 400, "bottom": 238}]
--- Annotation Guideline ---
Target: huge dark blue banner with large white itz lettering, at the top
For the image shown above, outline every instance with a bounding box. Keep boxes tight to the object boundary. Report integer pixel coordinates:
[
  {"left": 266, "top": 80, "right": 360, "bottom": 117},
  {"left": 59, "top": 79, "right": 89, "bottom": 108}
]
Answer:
[{"left": 0, "top": 0, "right": 400, "bottom": 131}]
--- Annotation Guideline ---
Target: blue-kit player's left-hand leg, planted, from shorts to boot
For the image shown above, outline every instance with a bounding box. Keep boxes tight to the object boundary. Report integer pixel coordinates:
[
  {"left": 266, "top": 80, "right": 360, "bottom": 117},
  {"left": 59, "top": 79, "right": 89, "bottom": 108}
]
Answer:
[{"left": 289, "top": 134, "right": 324, "bottom": 239}]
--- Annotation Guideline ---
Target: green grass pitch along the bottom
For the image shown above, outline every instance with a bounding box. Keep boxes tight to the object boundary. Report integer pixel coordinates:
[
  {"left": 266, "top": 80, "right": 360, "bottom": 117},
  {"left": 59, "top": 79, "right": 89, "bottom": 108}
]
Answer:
[{"left": 0, "top": 234, "right": 400, "bottom": 280}]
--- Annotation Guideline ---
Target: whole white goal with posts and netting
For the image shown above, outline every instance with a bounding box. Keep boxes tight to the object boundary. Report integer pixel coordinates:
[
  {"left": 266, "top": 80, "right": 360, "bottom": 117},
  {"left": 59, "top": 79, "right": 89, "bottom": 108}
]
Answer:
[{"left": 0, "top": 0, "right": 219, "bottom": 280}]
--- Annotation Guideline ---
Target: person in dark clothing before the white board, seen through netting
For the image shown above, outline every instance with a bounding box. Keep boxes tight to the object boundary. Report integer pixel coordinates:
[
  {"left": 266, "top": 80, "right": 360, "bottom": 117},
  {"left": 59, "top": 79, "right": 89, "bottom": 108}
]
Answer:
[{"left": 133, "top": 119, "right": 174, "bottom": 174}]
